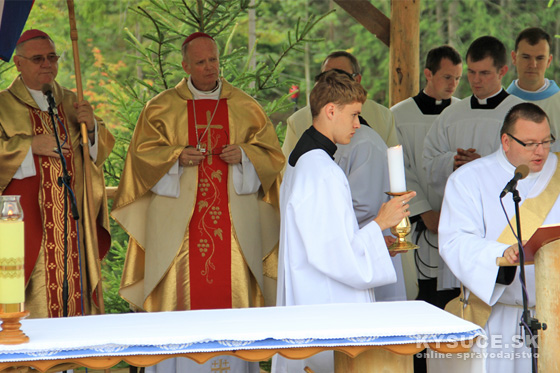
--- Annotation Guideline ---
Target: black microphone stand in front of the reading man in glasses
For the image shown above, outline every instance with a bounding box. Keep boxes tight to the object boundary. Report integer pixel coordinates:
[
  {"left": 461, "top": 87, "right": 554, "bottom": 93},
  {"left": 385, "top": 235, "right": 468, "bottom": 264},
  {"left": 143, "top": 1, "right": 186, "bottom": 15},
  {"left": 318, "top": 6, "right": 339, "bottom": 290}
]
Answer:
[{"left": 511, "top": 187, "right": 542, "bottom": 373}]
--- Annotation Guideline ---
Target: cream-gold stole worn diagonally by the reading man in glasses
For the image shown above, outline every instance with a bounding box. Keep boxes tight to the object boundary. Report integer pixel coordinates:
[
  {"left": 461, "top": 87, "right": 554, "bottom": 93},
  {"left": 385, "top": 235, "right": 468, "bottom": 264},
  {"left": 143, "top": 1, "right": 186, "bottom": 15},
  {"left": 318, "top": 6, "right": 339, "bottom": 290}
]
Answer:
[{"left": 445, "top": 158, "right": 560, "bottom": 328}]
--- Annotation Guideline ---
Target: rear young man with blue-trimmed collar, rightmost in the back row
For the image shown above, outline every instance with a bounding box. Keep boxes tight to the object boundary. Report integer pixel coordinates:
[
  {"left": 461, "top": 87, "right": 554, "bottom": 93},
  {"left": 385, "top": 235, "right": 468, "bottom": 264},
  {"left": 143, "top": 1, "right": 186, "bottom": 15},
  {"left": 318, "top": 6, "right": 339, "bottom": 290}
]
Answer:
[{"left": 507, "top": 27, "right": 560, "bottom": 151}]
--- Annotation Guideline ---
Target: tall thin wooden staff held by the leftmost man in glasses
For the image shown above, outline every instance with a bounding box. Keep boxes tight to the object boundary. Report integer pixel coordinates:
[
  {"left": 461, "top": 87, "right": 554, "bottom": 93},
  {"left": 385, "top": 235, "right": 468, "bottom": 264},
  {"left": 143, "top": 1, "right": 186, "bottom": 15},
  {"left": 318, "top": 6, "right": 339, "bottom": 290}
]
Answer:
[{"left": 67, "top": 0, "right": 105, "bottom": 313}]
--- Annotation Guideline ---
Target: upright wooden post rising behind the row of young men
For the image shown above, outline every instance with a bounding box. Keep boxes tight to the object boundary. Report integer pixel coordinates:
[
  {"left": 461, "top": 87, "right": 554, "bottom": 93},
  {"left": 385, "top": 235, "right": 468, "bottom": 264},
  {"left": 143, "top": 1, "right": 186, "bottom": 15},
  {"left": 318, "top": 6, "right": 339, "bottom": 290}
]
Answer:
[{"left": 389, "top": 0, "right": 420, "bottom": 106}]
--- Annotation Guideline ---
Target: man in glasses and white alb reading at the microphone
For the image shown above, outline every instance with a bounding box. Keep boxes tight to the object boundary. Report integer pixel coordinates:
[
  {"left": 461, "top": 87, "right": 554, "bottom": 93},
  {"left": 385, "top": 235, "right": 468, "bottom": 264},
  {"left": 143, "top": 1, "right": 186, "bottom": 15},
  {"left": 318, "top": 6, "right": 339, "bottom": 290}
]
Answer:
[{"left": 436, "top": 103, "right": 560, "bottom": 373}]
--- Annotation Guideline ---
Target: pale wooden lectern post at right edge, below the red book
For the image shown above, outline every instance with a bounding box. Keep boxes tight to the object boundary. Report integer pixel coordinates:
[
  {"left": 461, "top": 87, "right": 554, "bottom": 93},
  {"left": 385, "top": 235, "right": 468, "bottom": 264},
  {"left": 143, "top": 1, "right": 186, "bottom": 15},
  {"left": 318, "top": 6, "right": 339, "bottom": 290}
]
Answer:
[{"left": 535, "top": 241, "right": 560, "bottom": 372}]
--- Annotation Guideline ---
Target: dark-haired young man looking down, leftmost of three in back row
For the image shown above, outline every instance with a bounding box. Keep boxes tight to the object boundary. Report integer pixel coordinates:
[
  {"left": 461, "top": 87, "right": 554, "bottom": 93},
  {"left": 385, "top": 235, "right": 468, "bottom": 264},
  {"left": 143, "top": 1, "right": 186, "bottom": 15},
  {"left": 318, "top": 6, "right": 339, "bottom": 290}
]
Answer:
[{"left": 391, "top": 45, "right": 463, "bottom": 373}]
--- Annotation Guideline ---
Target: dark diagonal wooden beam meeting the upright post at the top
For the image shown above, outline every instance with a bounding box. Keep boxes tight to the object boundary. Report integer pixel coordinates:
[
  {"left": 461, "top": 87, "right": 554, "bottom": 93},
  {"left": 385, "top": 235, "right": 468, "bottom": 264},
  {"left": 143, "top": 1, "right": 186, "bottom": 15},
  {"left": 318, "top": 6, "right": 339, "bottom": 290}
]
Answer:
[{"left": 334, "top": 0, "right": 391, "bottom": 46}]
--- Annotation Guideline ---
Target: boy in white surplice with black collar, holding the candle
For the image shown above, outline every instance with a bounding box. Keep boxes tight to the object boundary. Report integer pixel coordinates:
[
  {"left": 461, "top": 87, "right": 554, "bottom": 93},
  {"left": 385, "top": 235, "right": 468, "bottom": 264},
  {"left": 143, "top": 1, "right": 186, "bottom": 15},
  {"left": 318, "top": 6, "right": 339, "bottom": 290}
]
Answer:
[{"left": 274, "top": 70, "right": 416, "bottom": 372}]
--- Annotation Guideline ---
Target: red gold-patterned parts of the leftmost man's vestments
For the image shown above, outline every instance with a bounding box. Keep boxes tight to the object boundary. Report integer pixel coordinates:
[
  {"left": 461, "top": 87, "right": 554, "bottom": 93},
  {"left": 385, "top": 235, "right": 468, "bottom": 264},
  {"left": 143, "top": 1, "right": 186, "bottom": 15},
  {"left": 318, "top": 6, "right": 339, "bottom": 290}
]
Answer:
[{"left": 4, "top": 105, "right": 82, "bottom": 317}]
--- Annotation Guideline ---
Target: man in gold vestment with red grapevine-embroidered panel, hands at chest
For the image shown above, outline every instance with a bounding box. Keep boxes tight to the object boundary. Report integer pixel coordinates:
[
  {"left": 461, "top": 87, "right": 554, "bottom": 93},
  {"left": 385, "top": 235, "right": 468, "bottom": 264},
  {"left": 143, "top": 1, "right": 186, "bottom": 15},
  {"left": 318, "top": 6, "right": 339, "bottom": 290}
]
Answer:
[{"left": 112, "top": 33, "right": 284, "bottom": 311}]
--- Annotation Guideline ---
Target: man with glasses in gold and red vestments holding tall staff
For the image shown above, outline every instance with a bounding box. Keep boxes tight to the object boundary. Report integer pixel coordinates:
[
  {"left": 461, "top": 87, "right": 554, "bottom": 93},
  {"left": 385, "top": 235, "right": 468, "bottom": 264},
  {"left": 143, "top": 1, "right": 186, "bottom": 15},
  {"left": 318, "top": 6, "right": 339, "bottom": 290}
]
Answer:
[{"left": 0, "top": 30, "right": 114, "bottom": 318}]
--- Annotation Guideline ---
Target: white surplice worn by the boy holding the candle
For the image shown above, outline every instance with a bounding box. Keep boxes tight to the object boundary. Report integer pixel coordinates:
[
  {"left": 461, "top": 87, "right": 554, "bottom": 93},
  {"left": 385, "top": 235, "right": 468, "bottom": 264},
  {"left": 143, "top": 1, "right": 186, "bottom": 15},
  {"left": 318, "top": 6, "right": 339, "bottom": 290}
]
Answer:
[{"left": 273, "top": 149, "right": 397, "bottom": 373}]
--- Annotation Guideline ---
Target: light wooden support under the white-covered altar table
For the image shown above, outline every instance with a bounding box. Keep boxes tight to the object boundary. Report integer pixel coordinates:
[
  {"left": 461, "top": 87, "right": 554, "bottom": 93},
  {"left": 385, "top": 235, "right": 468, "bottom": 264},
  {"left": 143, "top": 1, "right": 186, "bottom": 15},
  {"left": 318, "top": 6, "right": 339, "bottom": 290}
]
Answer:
[{"left": 334, "top": 348, "right": 413, "bottom": 373}]
